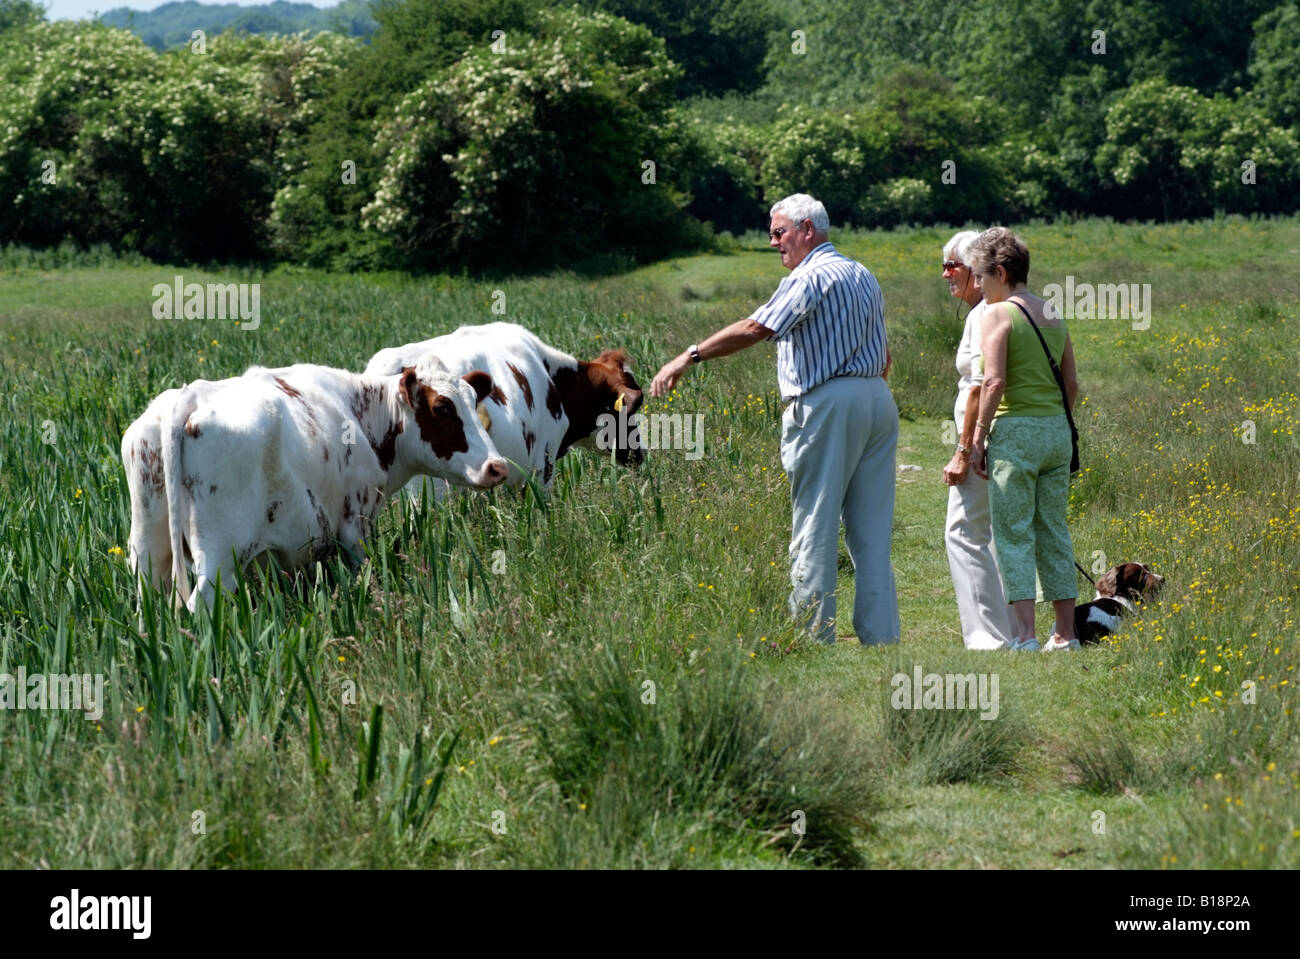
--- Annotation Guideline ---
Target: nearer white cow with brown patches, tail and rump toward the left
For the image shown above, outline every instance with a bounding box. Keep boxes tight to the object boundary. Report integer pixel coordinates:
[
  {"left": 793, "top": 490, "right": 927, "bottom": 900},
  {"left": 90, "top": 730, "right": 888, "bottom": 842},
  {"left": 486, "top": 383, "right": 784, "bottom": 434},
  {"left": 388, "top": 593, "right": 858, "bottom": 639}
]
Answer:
[{"left": 122, "top": 356, "right": 507, "bottom": 611}]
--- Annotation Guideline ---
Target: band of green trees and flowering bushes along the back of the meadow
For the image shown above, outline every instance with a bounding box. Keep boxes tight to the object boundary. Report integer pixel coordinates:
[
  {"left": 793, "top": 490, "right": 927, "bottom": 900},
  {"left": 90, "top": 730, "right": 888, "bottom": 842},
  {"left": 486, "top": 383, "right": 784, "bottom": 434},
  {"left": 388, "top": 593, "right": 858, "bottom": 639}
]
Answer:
[{"left": 0, "top": 0, "right": 1300, "bottom": 273}]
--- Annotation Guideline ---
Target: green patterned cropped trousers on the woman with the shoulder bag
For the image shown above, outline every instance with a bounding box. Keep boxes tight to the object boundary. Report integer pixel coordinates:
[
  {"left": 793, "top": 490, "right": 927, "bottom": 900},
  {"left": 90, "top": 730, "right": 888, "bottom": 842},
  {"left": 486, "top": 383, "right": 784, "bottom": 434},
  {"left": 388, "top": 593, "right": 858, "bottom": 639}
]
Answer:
[{"left": 987, "top": 413, "right": 1079, "bottom": 603}]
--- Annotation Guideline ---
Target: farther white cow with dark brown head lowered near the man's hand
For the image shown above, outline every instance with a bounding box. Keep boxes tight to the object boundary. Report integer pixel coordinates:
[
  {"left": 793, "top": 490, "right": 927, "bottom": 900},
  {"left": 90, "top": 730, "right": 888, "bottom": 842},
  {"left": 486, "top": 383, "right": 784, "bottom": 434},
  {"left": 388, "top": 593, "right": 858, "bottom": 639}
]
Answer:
[{"left": 365, "top": 322, "right": 645, "bottom": 492}]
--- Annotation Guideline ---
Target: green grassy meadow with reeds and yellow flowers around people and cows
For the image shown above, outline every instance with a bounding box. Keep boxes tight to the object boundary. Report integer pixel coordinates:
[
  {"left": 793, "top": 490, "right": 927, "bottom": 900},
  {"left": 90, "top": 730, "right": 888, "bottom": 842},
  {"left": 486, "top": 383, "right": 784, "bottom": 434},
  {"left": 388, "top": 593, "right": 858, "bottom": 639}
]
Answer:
[{"left": 0, "top": 218, "right": 1300, "bottom": 868}]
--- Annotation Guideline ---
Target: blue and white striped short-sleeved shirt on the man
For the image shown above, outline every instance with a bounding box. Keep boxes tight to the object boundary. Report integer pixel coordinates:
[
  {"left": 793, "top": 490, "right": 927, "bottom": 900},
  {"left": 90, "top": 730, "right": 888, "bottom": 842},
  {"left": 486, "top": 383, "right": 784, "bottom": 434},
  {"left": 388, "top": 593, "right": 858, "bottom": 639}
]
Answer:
[{"left": 751, "top": 242, "right": 885, "bottom": 402}]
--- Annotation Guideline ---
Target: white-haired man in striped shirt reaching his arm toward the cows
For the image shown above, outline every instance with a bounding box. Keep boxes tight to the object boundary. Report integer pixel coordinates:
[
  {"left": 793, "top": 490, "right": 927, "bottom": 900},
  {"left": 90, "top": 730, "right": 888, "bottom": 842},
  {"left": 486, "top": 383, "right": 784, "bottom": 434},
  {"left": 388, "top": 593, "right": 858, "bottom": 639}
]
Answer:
[{"left": 650, "top": 194, "right": 900, "bottom": 646}]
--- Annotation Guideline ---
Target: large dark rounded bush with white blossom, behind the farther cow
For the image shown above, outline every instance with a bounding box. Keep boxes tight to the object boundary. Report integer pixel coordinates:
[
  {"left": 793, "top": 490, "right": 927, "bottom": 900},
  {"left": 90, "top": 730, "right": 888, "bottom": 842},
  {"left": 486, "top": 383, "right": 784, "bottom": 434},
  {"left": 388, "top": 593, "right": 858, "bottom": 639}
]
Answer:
[{"left": 363, "top": 8, "right": 686, "bottom": 266}]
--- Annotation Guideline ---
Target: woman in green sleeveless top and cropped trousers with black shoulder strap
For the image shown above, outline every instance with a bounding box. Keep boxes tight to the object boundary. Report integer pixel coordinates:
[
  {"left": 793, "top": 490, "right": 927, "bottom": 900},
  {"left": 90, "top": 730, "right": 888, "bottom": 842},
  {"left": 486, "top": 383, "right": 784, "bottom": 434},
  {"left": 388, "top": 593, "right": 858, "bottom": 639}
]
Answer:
[{"left": 970, "top": 227, "right": 1079, "bottom": 651}]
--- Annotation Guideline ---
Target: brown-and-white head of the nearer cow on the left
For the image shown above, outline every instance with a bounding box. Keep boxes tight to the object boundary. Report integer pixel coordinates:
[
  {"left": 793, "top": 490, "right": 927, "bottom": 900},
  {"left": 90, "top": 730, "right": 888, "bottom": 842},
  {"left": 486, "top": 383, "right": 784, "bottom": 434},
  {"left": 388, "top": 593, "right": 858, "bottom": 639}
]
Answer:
[{"left": 398, "top": 356, "right": 507, "bottom": 489}]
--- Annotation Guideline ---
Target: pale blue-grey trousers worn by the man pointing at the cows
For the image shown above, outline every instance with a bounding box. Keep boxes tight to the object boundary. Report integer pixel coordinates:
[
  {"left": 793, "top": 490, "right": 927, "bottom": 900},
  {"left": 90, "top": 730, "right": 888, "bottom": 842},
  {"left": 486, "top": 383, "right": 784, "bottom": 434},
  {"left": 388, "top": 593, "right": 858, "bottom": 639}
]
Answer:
[{"left": 781, "top": 377, "right": 902, "bottom": 646}]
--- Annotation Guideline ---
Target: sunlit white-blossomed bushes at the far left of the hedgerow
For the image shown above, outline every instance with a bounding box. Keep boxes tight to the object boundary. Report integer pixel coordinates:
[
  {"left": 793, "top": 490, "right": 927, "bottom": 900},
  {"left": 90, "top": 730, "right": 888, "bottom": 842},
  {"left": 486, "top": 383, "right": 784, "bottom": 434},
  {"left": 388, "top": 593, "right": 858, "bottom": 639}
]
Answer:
[{"left": 0, "top": 22, "right": 355, "bottom": 260}]
